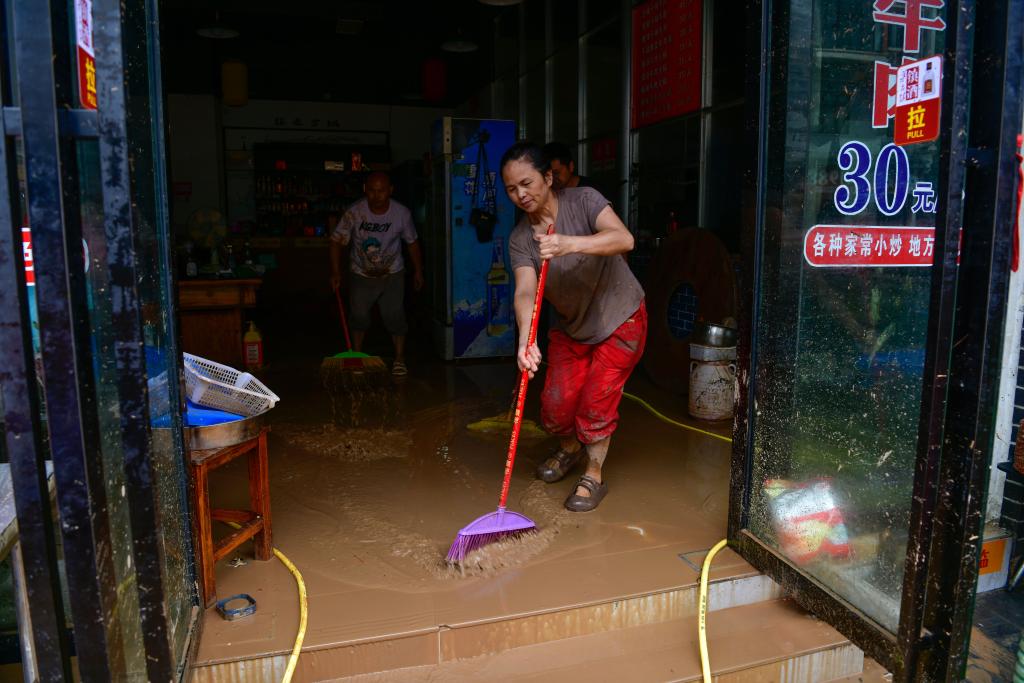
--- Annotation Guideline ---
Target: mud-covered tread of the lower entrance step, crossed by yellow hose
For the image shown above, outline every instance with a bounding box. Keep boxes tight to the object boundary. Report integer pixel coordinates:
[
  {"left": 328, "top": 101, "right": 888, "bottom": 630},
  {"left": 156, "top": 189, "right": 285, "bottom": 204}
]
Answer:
[{"left": 333, "top": 599, "right": 864, "bottom": 683}]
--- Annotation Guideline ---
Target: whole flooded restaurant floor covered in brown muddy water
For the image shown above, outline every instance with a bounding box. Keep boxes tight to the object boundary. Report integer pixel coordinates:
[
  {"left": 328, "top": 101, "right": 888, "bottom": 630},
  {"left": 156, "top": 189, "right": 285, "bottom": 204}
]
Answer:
[{"left": 196, "top": 356, "right": 752, "bottom": 666}]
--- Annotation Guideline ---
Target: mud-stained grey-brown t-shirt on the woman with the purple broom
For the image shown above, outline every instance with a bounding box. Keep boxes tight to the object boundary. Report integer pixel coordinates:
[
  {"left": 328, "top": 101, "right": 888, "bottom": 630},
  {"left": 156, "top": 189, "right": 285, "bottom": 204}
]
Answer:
[{"left": 509, "top": 187, "right": 644, "bottom": 344}]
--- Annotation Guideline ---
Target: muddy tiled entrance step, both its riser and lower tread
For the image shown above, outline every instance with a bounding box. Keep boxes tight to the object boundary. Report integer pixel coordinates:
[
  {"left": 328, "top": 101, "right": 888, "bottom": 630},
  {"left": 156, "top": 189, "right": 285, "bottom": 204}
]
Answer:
[{"left": 191, "top": 574, "right": 862, "bottom": 683}]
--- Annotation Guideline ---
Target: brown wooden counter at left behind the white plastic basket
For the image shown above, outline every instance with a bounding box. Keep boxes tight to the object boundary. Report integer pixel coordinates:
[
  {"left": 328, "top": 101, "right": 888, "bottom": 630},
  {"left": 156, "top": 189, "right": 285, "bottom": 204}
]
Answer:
[{"left": 178, "top": 279, "right": 262, "bottom": 370}]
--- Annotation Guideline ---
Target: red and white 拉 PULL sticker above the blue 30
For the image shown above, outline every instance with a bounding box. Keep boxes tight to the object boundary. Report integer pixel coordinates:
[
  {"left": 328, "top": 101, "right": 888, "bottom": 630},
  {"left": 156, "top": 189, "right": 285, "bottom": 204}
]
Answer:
[{"left": 893, "top": 55, "right": 942, "bottom": 145}]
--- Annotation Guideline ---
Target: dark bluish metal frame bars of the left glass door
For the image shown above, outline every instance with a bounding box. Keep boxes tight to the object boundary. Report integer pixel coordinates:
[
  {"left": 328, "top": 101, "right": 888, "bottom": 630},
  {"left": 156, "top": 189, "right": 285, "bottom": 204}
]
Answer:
[{"left": 0, "top": 0, "right": 198, "bottom": 681}]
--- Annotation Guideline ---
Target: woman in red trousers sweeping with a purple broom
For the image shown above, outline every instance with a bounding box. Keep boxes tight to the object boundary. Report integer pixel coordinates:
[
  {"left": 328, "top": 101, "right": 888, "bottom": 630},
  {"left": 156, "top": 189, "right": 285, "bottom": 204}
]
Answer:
[{"left": 502, "top": 141, "right": 647, "bottom": 512}]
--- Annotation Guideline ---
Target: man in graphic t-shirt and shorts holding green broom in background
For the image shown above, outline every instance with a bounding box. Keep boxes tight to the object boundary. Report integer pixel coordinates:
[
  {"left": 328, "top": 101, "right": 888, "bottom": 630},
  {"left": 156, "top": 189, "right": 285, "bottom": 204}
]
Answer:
[{"left": 331, "top": 171, "right": 423, "bottom": 375}]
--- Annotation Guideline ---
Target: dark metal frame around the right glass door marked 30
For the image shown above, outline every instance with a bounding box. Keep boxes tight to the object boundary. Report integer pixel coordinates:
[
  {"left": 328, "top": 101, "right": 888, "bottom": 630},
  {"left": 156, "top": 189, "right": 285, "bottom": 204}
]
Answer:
[{"left": 728, "top": 0, "right": 1024, "bottom": 681}]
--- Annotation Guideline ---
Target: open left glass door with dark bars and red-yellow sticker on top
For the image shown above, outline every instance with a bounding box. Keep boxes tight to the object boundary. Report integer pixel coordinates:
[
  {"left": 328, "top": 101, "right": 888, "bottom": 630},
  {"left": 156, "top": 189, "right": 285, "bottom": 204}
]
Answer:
[{"left": 0, "top": 0, "right": 199, "bottom": 681}]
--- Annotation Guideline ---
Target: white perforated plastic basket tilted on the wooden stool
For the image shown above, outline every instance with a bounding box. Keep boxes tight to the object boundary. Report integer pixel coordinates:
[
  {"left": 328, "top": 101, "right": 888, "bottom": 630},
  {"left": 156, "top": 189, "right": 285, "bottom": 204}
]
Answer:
[{"left": 182, "top": 353, "right": 281, "bottom": 417}]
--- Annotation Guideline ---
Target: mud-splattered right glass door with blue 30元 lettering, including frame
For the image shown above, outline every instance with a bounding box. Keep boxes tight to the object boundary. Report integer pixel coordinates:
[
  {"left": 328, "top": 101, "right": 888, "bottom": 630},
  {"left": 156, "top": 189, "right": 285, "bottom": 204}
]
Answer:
[{"left": 730, "top": 0, "right": 1021, "bottom": 680}]
